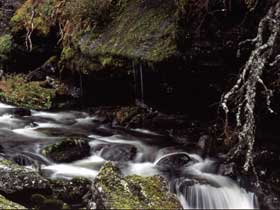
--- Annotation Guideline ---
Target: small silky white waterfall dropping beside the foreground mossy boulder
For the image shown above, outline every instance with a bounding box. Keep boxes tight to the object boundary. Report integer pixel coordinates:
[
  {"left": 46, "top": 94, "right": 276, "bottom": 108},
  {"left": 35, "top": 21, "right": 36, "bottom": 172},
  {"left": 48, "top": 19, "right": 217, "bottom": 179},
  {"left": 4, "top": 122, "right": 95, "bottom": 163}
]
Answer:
[{"left": 171, "top": 155, "right": 258, "bottom": 209}]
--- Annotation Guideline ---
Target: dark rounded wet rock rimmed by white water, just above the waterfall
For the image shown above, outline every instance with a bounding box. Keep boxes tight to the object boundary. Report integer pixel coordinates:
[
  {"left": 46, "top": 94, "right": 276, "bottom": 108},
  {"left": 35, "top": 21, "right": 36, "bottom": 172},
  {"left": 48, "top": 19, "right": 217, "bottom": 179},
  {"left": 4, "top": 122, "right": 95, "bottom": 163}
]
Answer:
[{"left": 155, "top": 152, "right": 191, "bottom": 172}]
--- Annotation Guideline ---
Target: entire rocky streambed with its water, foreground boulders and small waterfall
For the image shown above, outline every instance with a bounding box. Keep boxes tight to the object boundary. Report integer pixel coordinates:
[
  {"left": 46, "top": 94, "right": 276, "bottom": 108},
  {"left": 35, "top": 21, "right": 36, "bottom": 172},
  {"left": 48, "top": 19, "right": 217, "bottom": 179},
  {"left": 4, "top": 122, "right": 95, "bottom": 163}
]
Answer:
[{"left": 0, "top": 101, "right": 258, "bottom": 209}]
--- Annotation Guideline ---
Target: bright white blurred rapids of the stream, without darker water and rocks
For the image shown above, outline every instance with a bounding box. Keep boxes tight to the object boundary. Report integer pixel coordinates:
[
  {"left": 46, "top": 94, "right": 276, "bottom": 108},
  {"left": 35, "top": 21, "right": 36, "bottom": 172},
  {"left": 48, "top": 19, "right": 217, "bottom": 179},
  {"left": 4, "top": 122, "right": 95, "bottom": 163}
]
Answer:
[{"left": 0, "top": 103, "right": 258, "bottom": 209}]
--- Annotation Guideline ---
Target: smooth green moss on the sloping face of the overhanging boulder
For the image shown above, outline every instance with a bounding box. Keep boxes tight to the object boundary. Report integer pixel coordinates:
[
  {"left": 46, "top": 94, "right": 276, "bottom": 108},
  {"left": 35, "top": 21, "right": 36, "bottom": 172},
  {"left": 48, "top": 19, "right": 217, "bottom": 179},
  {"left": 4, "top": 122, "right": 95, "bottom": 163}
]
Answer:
[{"left": 81, "top": 0, "right": 176, "bottom": 62}]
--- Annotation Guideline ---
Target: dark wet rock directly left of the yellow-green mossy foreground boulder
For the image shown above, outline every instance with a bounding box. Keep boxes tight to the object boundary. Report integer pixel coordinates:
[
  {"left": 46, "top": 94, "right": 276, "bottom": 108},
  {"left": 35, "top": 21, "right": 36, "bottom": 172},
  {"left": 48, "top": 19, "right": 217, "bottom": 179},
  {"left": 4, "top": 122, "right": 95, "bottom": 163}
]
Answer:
[{"left": 51, "top": 177, "right": 92, "bottom": 207}]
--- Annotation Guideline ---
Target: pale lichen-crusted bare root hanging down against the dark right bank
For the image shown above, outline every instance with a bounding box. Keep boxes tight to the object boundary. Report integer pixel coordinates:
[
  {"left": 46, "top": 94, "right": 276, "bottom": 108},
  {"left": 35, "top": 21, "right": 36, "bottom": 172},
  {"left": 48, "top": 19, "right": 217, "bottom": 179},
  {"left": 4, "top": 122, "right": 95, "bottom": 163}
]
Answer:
[{"left": 221, "top": 1, "right": 280, "bottom": 174}]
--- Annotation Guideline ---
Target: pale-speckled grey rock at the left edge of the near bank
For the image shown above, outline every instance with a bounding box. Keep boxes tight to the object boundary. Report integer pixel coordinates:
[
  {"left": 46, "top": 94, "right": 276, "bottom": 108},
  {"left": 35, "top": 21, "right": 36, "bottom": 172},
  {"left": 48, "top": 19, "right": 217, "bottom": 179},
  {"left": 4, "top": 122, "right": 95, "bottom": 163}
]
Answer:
[{"left": 0, "top": 159, "right": 51, "bottom": 205}]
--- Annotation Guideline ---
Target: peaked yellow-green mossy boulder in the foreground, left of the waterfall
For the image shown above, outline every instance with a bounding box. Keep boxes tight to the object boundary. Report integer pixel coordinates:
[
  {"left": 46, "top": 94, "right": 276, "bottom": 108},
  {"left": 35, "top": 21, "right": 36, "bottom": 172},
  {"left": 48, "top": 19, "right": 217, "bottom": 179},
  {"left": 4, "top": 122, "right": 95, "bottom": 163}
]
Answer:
[{"left": 88, "top": 162, "right": 182, "bottom": 209}]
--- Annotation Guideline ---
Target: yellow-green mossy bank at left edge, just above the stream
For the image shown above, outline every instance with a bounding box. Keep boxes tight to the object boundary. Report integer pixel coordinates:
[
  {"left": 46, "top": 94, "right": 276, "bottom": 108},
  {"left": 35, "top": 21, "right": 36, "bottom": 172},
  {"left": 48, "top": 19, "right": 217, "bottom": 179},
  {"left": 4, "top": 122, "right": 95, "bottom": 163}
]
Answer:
[{"left": 0, "top": 74, "right": 55, "bottom": 109}]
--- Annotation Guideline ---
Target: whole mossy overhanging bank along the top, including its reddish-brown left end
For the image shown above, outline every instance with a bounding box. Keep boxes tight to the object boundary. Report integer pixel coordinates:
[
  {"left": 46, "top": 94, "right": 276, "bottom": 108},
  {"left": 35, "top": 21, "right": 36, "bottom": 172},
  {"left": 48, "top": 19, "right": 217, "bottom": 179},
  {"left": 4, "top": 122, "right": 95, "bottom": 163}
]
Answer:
[{"left": 11, "top": 0, "right": 178, "bottom": 72}]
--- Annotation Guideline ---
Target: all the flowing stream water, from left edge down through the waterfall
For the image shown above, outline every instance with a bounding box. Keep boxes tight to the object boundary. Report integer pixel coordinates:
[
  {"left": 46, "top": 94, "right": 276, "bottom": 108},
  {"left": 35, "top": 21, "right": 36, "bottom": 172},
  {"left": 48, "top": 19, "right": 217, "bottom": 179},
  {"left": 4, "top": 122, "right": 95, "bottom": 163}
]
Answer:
[{"left": 0, "top": 103, "right": 258, "bottom": 209}]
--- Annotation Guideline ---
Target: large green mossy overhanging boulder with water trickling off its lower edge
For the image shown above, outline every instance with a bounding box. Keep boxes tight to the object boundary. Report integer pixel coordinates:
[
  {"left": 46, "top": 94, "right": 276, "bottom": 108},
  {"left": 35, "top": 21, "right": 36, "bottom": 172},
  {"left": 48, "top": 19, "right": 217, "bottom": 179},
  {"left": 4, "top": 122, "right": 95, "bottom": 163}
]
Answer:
[{"left": 62, "top": 0, "right": 178, "bottom": 71}]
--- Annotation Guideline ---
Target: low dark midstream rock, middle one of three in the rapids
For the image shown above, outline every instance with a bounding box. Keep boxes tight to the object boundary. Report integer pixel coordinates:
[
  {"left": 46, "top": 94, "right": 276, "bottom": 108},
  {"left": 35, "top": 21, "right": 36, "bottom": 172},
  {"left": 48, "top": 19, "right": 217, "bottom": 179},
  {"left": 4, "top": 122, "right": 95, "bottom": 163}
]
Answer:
[{"left": 94, "top": 144, "right": 137, "bottom": 161}]
